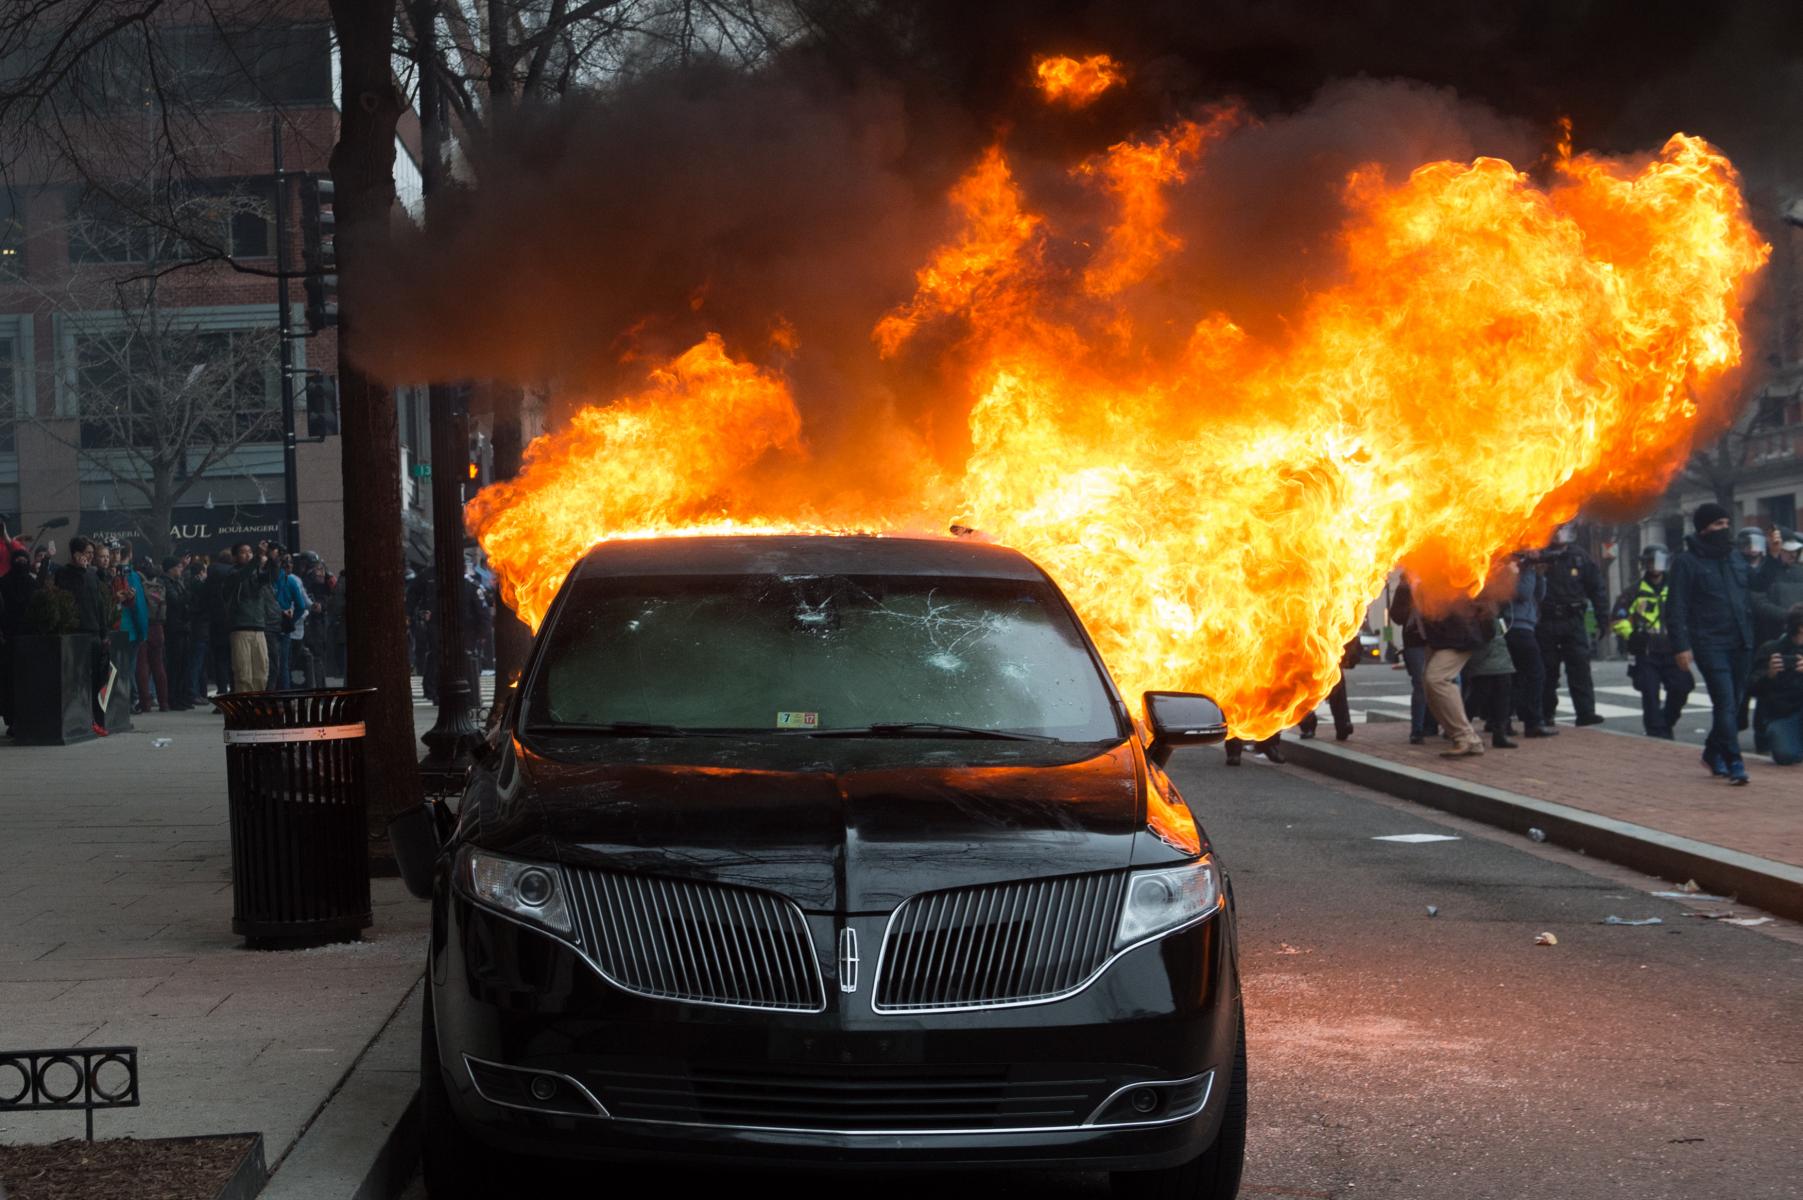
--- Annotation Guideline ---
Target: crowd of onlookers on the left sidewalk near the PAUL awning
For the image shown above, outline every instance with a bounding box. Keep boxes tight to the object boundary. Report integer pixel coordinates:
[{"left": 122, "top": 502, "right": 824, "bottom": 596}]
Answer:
[{"left": 0, "top": 526, "right": 344, "bottom": 737}]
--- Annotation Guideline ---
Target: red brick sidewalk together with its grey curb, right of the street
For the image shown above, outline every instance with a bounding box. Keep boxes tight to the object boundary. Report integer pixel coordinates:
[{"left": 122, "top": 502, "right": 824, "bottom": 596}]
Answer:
[{"left": 1284, "top": 721, "right": 1803, "bottom": 919}]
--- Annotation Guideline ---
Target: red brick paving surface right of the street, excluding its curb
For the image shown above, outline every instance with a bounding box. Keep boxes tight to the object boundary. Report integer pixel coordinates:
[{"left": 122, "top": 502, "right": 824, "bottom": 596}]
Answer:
[{"left": 1322, "top": 721, "right": 1803, "bottom": 867}]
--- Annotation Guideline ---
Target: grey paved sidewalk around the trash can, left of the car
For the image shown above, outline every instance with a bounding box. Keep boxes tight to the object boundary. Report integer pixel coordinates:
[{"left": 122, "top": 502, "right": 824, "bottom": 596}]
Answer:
[{"left": 0, "top": 710, "right": 431, "bottom": 1178}]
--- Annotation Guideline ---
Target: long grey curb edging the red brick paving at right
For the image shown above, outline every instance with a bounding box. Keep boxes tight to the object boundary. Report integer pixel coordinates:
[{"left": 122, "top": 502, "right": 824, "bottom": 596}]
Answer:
[{"left": 1284, "top": 741, "right": 1803, "bottom": 921}]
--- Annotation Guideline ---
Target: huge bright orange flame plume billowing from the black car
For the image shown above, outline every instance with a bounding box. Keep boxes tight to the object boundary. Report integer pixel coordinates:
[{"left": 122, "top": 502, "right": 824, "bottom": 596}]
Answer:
[{"left": 469, "top": 110, "right": 1769, "bottom": 737}]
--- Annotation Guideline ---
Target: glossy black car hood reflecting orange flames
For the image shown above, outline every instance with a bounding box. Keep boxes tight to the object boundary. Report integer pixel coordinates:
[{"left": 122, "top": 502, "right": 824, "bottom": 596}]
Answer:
[{"left": 472, "top": 739, "right": 1153, "bottom": 912}]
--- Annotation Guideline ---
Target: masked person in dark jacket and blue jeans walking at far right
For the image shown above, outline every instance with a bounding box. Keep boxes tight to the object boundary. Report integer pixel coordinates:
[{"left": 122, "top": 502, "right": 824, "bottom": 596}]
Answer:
[{"left": 1666, "top": 501, "right": 1785, "bottom": 784}]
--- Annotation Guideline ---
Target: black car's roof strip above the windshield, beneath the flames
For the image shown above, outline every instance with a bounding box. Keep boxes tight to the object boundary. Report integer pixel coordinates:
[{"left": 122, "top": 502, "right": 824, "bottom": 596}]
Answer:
[{"left": 577, "top": 533, "right": 1046, "bottom": 580}]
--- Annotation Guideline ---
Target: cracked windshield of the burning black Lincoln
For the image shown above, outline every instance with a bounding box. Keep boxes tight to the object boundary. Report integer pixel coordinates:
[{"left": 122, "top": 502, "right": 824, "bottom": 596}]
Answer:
[{"left": 525, "top": 575, "right": 1125, "bottom": 741}]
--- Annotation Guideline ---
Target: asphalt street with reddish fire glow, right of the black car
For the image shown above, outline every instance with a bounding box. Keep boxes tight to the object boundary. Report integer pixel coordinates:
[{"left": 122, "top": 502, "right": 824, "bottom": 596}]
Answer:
[{"left": 398, "top": 742, "right": 1803, "bottom": 1200}]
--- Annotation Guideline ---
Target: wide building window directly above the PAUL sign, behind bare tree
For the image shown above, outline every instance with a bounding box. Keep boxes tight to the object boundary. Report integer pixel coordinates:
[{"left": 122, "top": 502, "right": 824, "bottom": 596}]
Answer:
[{"left": 74, "top": 328, "right": 281, "bottom": 450}]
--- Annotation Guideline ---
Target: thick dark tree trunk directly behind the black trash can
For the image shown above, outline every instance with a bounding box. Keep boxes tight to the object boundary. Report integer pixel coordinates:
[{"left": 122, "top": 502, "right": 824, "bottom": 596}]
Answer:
[{"left": 332, "top": 0, "right": 422, "bottom": 836}]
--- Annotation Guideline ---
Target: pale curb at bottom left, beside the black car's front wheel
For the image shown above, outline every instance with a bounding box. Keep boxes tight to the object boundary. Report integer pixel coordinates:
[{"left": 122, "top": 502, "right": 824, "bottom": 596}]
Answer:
[{"left": 261, "top": 980, "right": 426, "bottom": 1200}]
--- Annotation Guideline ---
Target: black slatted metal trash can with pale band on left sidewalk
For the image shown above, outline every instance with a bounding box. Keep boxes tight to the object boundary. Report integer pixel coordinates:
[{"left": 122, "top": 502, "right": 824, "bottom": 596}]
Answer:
[{"left": 213, "top": 688, "right": 375, "bottom": 944}]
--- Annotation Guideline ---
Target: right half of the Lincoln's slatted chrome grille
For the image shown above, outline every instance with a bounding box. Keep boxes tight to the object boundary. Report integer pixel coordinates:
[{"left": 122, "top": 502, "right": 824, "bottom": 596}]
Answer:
[{"left": 874, "top": 870, "right": 1127, "bottom": 1013}]
